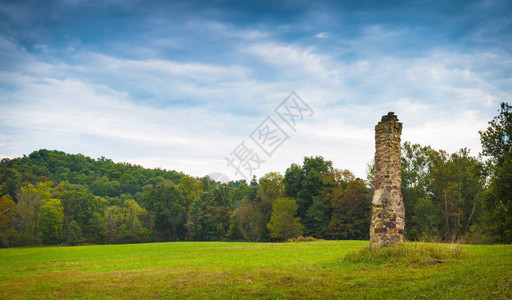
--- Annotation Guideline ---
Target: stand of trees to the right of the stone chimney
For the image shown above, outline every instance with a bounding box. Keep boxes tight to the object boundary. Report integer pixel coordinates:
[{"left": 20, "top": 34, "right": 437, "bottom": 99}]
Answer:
[{"left": 402, "top": 103, "right": 512, "bottom": 243}]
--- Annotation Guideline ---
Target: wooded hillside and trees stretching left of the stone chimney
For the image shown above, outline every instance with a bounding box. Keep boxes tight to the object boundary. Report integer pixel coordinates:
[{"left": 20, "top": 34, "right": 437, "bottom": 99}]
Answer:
[{"left": 0, "top": 150, "right": 371, "bottom": 247}]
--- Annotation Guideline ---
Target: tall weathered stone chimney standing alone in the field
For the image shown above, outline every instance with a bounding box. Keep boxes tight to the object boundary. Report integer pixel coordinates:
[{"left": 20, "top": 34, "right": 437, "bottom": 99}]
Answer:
[{"left": 370, "top": 112, "right": 405, "bottom": 248}]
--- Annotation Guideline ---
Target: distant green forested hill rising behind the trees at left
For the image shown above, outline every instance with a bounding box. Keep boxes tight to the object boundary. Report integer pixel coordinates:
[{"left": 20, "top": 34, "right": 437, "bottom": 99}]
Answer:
[{"left": 0, "top": 149, "right": 184, "bottom": 198}]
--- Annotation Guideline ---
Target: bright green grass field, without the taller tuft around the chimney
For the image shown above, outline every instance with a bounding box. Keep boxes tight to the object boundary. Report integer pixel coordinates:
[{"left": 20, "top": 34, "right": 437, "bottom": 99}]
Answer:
[{"left": 0, "top": 241, "right": 512, "bottom": 299}]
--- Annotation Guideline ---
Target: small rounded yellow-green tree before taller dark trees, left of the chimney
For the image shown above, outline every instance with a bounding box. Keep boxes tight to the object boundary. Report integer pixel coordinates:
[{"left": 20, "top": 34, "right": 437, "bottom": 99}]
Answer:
[{"left": 267, "top": 198, "right": 302, "bottom": 241}]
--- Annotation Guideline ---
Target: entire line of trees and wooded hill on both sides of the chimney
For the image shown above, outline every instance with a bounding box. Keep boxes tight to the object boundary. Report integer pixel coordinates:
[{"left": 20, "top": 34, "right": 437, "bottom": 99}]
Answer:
[{"left": 0, "top": 103, "right": 512, "bottom": 247}]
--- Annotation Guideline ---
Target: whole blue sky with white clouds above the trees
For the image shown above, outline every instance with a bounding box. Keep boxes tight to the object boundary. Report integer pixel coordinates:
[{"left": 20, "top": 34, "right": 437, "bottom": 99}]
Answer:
[{"left": 0, "top": 0, "right": 512, "bottom": 179}]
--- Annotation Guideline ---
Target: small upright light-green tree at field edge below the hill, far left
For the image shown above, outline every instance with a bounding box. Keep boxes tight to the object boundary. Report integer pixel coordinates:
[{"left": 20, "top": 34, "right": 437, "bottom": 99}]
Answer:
[{"left": 38, "top": 198, "right": 64, "bottom": 244}]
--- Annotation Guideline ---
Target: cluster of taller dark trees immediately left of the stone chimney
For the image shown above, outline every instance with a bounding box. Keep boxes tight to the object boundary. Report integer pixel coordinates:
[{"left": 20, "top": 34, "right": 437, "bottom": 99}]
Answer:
[{"left": 283, "top": 156, "right": 370, "bottom": 239}]
